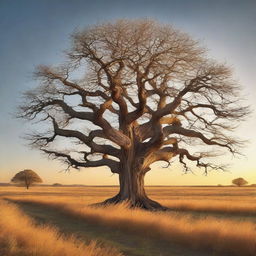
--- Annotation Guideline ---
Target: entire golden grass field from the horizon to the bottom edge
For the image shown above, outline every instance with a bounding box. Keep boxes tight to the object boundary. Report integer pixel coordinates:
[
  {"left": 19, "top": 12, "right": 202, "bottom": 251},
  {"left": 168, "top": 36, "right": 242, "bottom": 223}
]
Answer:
[{"left": 0, "top": 187, "right": 256, "bottom": 256}]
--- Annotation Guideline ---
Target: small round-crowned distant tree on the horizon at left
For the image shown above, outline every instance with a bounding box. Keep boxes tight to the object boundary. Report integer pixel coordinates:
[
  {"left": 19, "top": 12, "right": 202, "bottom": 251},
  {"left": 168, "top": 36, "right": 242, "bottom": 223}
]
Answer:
[{"left": 11, "top": 170, "right": 43, "bottom": 189}]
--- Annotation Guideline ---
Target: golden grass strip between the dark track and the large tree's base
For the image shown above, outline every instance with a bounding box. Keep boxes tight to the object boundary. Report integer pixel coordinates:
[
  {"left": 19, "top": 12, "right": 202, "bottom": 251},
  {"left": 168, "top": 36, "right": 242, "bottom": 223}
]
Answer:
[{"left": 8, "top": 200, "right": 256, "bottom": 256}]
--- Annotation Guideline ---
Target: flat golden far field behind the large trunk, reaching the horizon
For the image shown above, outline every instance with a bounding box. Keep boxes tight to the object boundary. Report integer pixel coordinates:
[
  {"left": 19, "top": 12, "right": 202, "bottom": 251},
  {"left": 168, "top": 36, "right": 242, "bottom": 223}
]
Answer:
[{"left": 0, "top": 187, "right": 256, "bottom": 216}]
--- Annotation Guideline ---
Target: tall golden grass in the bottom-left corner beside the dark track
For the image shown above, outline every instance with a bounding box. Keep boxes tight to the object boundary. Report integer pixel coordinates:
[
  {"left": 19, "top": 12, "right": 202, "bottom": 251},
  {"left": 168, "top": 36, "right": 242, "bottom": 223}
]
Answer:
[{"left": 0, "top": 201, "right": 121, "bottom": 256}]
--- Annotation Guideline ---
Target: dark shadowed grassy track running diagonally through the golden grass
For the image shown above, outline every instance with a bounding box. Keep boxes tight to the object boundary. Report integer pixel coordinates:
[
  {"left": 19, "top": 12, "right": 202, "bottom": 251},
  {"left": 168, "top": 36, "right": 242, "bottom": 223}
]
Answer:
[{"left": 10, "top": 201, "right": 205, "bottom": 256}]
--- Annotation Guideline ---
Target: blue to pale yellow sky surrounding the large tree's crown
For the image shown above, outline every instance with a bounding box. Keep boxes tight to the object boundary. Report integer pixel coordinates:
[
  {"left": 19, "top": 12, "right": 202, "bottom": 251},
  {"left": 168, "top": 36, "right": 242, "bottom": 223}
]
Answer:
[{"left": 0, "top": 0, "right": 256, "bottom": 185}]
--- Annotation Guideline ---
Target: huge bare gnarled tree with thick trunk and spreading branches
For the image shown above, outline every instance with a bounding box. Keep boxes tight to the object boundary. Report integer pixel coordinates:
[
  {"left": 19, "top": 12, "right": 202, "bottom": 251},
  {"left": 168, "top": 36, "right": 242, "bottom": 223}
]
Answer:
[{"left": 19, "top": 20, "right": 248, "bottom": 209}]
